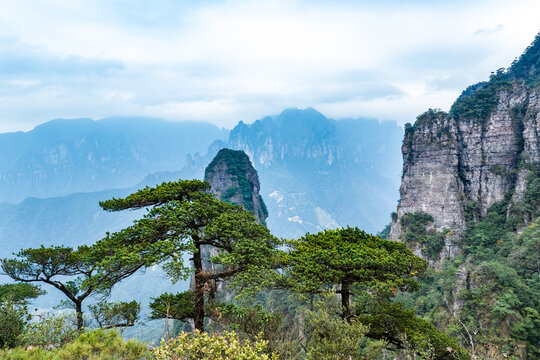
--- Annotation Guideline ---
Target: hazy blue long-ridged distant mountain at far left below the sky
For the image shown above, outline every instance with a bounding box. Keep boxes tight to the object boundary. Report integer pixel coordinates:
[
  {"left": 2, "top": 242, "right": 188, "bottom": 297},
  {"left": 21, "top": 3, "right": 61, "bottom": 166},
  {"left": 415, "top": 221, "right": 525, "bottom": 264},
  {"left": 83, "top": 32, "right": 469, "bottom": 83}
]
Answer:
[{"left": 0, "top": 117, "right": 228, "bottom": 202}]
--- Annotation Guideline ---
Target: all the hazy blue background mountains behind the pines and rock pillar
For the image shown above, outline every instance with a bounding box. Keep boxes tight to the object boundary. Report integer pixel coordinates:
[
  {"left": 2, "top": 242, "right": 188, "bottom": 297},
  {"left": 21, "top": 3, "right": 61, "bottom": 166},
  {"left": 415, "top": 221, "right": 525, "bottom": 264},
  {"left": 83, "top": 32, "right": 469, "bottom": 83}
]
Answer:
[{"left": 0, "top": 108, "right": 403, "bottom": 318}]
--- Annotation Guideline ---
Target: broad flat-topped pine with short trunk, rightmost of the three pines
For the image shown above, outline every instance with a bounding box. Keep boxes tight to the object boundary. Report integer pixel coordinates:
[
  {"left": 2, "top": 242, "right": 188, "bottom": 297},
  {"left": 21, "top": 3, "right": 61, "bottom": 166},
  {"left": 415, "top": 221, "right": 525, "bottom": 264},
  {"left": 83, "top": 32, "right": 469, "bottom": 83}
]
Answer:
[{"left": 285, "top": 227, "right": 427, "bottom": 318}]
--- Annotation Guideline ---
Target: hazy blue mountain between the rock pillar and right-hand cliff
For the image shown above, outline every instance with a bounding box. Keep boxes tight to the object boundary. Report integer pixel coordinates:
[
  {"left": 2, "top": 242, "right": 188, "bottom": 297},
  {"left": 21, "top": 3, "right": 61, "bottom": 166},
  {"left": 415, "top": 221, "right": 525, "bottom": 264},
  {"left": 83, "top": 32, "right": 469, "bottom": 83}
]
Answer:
[{"left": 183, "top": 108, "right": 403, "bottom": 238}]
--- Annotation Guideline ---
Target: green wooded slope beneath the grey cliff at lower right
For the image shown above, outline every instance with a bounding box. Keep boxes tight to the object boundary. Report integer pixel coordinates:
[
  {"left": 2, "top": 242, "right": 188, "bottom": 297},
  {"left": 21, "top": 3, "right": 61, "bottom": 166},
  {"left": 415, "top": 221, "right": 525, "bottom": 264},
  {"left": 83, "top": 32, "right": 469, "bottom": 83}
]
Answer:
[{"left": 405, "top": 210, "right": 540, "bottom": 359}]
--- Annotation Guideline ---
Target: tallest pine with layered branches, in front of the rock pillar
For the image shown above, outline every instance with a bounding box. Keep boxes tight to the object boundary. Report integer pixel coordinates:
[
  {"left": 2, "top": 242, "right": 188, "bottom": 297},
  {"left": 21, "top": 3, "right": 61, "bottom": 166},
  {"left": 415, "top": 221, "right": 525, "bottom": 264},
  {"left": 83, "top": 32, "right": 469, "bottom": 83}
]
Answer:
[{"left": 97, "top": 180, "right": 279, "bottom": 331}]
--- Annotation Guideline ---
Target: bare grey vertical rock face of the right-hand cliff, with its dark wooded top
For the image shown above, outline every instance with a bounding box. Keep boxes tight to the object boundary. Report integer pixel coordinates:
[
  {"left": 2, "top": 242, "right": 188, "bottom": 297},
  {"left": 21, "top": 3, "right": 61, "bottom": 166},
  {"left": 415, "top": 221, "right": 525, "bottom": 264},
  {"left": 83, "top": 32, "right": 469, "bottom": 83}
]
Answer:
[{"left": 389, "top": 33, "right": 540, "bottom": 260}]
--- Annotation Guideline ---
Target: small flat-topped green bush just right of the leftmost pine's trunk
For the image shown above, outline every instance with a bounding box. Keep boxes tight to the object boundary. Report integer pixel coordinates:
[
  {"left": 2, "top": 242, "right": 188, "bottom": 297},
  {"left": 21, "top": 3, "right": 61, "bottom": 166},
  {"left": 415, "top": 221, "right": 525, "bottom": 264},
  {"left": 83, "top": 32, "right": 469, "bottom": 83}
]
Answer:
[{"left": 88, "top": 301, "right": 141, "bottom": 328}]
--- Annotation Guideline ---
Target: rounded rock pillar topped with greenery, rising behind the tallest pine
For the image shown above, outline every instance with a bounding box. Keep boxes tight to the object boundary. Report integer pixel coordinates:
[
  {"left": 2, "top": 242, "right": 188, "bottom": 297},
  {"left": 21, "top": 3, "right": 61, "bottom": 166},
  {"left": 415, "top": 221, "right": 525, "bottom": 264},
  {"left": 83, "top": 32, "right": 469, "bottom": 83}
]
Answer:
[{"left": 204, "top": 149, "right": 268, "bottom": 224}]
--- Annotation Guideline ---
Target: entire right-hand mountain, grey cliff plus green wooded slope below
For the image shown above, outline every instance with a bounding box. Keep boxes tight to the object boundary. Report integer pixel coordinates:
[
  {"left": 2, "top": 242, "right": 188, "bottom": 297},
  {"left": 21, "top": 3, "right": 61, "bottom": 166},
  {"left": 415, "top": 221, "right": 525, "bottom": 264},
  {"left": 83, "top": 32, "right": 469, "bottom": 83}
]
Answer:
[{"left": 389, "top": 34, "right": 540, "bottom": 359}]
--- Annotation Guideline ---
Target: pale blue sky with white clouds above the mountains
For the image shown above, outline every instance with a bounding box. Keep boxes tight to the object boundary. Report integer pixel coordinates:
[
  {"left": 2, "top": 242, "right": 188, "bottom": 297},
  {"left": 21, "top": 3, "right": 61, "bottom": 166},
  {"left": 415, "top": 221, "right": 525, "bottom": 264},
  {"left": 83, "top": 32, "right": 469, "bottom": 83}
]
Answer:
[{"left": 0, "top": 0, "right": 540, "bottom": 132}]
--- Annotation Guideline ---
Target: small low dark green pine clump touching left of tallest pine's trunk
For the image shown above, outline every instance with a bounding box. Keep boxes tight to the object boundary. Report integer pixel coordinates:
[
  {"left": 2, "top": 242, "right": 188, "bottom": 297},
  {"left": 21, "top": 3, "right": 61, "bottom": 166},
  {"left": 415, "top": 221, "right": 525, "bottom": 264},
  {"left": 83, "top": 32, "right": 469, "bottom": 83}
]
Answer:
[{"left": 150, "top": 290, "right": 195, "bottom": 321}]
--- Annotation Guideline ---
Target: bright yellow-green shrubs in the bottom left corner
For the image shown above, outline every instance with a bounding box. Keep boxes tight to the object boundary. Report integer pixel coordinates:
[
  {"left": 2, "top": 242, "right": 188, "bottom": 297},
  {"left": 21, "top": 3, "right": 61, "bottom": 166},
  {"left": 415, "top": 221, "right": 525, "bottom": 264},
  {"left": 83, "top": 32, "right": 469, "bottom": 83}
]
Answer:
[{"left": 0, "top": 329, "right": 151, "bottom": 360}]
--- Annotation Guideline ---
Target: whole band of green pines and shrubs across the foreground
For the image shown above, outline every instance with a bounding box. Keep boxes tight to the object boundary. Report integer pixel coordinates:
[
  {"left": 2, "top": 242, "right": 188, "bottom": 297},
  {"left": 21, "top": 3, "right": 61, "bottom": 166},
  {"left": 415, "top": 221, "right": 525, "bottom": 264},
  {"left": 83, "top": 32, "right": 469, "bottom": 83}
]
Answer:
[{"left": 0, "top": 180, "right": 480, "bottom": 360}]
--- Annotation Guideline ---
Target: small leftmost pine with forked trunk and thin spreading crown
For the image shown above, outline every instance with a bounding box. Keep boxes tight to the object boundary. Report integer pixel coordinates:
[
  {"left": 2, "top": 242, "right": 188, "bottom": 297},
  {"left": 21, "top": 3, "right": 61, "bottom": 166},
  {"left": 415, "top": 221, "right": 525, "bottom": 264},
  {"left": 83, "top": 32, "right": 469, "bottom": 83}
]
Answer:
[{"left": 1, "top": 246, "right": 139, "bottom": 330}]
